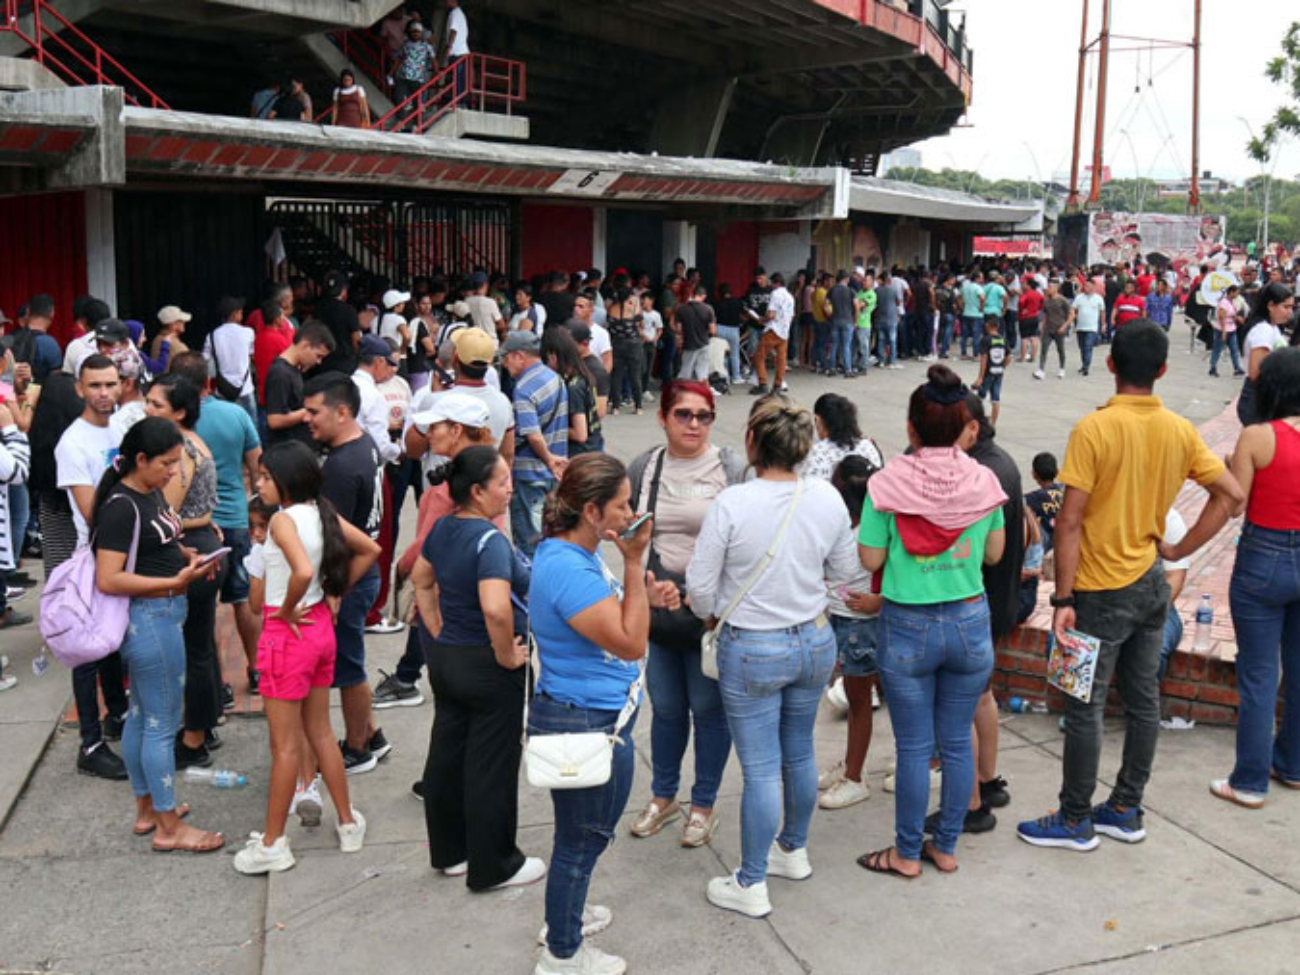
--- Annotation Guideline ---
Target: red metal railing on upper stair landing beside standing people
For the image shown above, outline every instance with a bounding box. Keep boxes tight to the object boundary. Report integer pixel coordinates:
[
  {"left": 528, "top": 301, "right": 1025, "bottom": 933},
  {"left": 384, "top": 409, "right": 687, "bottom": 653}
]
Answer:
[{"left": 371, "top": 55, "right": 528, "bottom": 134}]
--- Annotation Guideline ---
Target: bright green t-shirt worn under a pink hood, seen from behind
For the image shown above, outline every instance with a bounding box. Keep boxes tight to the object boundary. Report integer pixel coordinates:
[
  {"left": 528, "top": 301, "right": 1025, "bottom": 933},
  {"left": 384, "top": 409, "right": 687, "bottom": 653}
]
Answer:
[{"left": 858, "top": 495, "right": 1006, "bottom": 606}]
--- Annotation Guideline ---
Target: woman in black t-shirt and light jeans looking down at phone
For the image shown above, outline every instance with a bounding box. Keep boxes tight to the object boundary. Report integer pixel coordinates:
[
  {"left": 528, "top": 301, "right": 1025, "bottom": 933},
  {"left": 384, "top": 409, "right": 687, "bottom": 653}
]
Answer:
[{"left": 91, "top": 417, "right": 225, "bottom": 853}]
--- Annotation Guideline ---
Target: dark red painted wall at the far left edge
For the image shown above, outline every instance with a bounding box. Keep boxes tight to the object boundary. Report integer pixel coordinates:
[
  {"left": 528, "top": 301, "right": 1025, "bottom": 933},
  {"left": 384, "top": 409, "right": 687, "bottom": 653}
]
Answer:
[{"left": 0, "top": 192, "right": 86, "bottom": 345}]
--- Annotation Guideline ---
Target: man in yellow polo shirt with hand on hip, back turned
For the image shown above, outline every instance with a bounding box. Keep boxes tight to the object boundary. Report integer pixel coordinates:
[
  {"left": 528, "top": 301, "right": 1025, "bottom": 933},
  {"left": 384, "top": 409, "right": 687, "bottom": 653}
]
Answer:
[{"left": 1017, "top": 319, "right": 1245, "bottom": 850}]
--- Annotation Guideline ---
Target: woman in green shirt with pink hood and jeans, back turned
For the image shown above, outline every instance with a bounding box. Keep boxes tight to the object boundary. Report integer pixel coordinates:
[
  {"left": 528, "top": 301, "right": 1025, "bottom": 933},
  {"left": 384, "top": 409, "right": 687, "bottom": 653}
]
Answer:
[{"left": 858, "top": 365, "right": 1006, "bottom": 879}]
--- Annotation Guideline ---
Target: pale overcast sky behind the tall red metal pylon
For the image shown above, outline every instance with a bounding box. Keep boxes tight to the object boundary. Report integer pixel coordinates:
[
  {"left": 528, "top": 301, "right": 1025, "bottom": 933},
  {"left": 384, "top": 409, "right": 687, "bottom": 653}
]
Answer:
[{"left": 913, "top": 0, "right": 1300, "bottom": 182}]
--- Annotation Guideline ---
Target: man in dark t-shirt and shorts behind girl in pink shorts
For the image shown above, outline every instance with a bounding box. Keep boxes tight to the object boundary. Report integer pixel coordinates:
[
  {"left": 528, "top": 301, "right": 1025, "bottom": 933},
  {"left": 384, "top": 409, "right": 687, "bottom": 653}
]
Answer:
[{"left": 303, "top": 372, "right": 393, "bottom": 775}]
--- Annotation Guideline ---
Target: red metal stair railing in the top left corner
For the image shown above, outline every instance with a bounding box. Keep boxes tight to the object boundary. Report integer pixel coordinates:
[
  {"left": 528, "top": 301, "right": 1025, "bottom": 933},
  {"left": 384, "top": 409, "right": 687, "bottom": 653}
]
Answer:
[{"left": 0, "top": 0, "right": 168, "bottom": 109}]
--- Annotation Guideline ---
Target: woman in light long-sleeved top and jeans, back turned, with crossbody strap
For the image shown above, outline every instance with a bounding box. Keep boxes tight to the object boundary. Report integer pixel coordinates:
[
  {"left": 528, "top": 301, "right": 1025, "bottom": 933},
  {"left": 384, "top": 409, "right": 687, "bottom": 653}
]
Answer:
[{"left": 686, "top": 395, "right": 858, "bottom": 918}]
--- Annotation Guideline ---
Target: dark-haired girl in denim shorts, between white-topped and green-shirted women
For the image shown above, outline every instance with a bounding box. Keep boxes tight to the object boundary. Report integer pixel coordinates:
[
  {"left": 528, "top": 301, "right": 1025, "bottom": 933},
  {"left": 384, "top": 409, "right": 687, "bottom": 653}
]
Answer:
[{"left": 818, "top": 454, "right": 881, "bottom": 809}]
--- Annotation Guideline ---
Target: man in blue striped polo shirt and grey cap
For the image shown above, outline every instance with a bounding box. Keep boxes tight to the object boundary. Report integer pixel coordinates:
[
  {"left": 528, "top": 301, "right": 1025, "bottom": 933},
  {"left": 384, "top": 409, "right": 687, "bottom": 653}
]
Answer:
[{"left": 502, "top": 332, "right": 568, "bottom": 558}]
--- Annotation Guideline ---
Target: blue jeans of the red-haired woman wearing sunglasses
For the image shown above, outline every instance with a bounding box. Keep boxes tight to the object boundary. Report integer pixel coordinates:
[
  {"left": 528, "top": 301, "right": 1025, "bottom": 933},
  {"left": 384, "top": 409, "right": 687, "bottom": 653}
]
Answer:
[{"left": 646, "top": 644, "right": 731, "bottom": 809}]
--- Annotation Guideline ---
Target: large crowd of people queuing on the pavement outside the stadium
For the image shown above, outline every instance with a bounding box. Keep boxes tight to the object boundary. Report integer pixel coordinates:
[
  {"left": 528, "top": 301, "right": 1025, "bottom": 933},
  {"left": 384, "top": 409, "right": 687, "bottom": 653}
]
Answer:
[{"left": 0, "top": 253, "right": 1300, "bottom": 975}]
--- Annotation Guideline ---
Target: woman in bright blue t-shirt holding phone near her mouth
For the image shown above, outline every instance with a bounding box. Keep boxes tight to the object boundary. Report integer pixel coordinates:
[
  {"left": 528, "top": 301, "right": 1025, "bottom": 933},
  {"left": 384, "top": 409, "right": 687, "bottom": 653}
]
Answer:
[{"left": 528, "top": 454, "right": 655, "bottom": 975}]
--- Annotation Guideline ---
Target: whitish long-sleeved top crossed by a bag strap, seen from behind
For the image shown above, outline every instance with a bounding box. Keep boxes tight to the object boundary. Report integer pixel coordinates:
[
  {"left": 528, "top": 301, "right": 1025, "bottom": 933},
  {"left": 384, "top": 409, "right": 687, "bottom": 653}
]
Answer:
[{"left": 686, "top": 480, "right": 861, "bottom": 629}]
